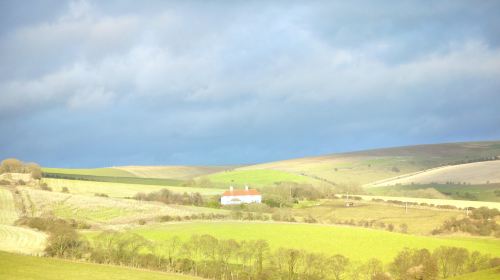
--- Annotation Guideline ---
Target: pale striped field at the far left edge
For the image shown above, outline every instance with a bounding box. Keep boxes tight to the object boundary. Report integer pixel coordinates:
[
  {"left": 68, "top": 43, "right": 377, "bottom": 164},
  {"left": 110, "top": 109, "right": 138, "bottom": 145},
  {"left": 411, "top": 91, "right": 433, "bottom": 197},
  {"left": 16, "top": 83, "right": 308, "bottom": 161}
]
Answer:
[{"left": 0, "top": 187, "right": 47, "bottom": 255}]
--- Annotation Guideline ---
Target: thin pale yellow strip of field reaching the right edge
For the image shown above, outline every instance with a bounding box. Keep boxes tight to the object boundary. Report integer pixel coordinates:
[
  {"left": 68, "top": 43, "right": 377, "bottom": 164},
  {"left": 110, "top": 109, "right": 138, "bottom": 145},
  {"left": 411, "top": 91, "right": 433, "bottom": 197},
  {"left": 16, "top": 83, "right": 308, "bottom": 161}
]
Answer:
[{"left": 357, "top": 195, "right": 500, "bottom": 210}]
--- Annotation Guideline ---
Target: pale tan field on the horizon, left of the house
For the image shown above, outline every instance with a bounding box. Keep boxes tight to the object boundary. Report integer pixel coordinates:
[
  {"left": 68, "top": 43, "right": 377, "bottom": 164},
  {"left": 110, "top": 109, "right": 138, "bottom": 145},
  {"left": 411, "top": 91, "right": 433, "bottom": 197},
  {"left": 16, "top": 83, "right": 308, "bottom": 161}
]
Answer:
[{"left": 113, "top": 165, "right": 231, "bottom": 179}]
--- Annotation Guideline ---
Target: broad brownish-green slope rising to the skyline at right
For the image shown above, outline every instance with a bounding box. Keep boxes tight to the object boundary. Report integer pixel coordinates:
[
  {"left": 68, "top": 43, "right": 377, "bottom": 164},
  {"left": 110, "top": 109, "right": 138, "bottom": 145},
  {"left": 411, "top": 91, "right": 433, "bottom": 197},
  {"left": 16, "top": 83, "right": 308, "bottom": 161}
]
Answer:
[{"left": 229, "top": 141, "right": 500, "bottom": 187}]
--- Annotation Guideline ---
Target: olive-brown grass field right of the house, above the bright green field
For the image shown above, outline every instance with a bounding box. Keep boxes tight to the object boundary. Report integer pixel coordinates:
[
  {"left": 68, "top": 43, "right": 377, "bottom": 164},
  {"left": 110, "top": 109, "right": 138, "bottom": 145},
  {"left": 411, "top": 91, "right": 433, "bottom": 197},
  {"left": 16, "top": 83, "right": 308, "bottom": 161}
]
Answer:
[{"left": 292, "top": 200, "right": 463, "bottom": 235}]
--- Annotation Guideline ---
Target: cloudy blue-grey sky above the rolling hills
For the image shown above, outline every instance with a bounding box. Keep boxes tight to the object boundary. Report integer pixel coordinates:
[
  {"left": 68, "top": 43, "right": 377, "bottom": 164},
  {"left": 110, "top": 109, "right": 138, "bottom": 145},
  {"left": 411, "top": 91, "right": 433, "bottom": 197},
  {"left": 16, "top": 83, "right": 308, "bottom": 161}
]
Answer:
[{"left": 0, "top": 0, "right": 500, "bottom": 167}]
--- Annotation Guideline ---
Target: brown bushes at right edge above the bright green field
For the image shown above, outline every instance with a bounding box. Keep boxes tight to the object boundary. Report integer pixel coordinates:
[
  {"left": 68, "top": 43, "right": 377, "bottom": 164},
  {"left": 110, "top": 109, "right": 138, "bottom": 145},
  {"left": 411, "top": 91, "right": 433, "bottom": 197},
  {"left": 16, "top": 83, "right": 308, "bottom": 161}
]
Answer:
[{"left": 432, "top": 207, "right": 500, "bottom": 237}]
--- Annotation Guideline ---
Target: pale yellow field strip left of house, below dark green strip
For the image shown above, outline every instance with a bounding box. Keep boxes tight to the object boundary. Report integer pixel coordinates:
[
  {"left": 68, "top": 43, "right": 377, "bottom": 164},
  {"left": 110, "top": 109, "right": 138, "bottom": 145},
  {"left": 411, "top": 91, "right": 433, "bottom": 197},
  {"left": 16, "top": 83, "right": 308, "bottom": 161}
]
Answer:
[{"left": 42, "top": 178, "right": 225, "bottom": 198}]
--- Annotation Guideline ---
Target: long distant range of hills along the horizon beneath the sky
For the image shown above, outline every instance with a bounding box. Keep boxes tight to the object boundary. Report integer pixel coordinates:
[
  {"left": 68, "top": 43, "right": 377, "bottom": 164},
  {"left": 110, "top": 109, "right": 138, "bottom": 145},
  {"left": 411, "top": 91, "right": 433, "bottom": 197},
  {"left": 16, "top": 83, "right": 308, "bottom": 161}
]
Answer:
[{"left": 43, "top": 141, "right": 500, "bottom": 190}]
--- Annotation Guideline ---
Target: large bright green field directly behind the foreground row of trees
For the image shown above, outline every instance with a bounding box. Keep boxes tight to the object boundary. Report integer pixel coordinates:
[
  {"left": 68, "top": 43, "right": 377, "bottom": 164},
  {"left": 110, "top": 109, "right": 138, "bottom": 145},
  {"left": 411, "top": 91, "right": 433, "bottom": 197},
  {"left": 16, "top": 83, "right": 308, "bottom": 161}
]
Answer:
[{"left": 132, "top": 222, "right": 500, "bottom": 263}]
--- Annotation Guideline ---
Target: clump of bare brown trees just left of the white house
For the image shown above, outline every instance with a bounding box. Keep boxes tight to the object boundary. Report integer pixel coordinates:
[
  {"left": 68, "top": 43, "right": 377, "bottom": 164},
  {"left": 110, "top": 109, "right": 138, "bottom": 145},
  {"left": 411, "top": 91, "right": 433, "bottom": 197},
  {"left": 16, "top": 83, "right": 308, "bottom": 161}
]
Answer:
[{"left": 133, "top": 189, "right": 204, "bottom": 206}]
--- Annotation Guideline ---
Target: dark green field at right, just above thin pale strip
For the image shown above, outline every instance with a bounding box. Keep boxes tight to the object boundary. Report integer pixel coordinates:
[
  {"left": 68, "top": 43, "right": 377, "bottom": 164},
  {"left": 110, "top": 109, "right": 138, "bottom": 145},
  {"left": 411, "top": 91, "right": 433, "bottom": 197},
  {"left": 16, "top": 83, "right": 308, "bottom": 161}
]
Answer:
[{"left": 366, "top": 183, "right": 500, "bottom": 202}]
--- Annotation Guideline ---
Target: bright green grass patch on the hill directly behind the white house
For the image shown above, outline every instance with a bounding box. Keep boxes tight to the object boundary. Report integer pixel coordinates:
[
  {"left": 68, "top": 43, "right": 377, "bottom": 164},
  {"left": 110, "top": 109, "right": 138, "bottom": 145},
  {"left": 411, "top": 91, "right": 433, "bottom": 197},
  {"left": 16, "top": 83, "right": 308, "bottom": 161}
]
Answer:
[{"left": 206, "top": 169, "right": 314, "bottom": 187}]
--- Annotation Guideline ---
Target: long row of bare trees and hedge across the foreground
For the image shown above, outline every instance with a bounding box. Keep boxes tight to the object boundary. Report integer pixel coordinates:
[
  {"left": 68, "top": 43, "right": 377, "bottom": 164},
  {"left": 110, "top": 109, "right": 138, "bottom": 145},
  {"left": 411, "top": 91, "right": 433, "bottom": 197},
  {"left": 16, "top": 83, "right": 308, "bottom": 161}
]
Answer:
[{"left": 16, "top": 218, "right": 500, "bottom": 280}]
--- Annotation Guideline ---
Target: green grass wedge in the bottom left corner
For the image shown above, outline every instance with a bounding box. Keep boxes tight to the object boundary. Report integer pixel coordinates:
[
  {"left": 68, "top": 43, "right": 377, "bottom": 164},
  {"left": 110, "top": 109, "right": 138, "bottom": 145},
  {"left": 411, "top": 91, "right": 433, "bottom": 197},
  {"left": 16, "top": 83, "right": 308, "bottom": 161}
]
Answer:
[{"left": 0, "top": 252, "right": 201, "bottom": 280}]
